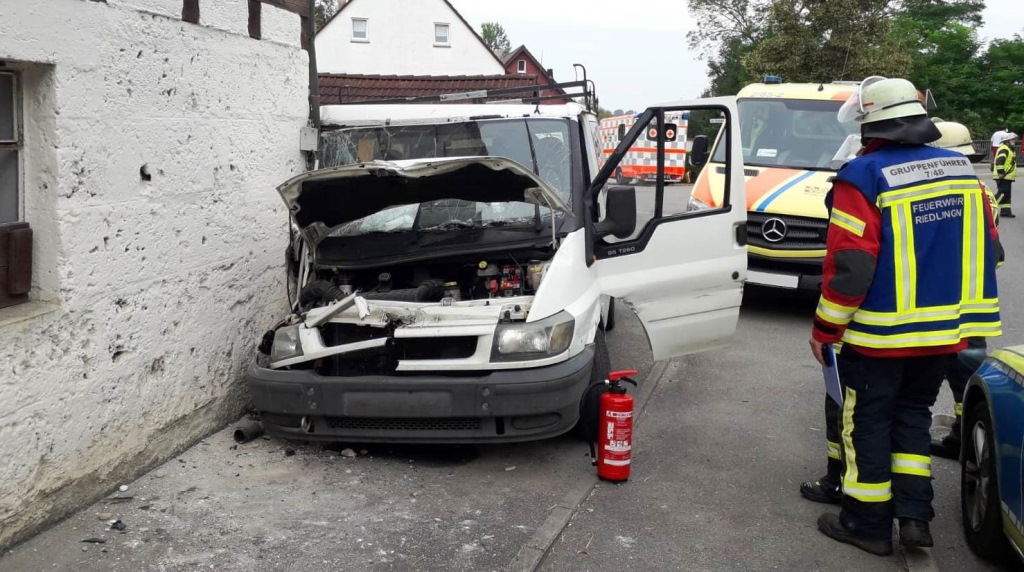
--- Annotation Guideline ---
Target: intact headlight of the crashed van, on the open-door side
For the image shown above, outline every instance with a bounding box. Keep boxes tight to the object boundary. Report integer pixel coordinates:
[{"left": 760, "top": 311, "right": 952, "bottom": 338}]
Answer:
[{"left": 490, "top": 310, "right": 575, "bottom": 361}]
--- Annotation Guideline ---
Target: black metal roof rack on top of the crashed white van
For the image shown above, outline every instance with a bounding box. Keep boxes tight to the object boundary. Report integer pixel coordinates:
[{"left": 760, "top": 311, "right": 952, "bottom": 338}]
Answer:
[{"left": 339, "top": 79, "right": 597, "bottom": 113}]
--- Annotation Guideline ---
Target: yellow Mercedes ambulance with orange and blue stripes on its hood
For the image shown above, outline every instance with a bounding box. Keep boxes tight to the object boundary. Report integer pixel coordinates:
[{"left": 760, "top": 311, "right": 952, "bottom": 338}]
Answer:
[{"left": 688, "top": 77, "right": 860, "bottom": 290}]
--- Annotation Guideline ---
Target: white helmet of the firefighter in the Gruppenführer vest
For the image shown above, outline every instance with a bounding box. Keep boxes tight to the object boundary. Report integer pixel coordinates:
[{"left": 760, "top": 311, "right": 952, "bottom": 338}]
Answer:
[{"left": 838, "top": 76, "right": 928, "bottom": 123}]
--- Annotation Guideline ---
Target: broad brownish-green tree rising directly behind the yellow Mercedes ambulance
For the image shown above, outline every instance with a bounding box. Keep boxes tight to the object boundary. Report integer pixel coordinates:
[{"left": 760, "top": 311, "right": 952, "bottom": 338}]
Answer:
[{"left": 742, "top": 0, "right": 911, "bottom": 82}]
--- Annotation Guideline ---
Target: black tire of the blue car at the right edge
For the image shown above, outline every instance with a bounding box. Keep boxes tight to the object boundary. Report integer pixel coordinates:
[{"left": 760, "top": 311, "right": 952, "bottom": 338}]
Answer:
[{"left": 961, "top": 401, "right": 1013, "bottom": 562}]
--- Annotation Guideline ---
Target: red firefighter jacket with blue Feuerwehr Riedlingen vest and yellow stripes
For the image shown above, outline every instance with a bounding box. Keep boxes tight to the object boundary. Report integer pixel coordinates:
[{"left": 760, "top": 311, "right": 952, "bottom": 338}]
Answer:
[{"left": 812, "top": 140, "right": 1000, "bottom": 356}]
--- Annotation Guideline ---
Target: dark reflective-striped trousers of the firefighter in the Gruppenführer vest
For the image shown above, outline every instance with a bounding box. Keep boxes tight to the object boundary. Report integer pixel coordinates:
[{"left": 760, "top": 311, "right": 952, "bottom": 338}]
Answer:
[{"left": 837, "top": 344, "right": 953, "bottom": 540}]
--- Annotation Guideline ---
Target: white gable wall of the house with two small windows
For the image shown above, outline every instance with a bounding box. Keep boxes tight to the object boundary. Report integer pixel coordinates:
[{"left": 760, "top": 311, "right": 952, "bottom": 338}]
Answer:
[{"left": 316, "top": 0, "right": 505, "bottom": 76}]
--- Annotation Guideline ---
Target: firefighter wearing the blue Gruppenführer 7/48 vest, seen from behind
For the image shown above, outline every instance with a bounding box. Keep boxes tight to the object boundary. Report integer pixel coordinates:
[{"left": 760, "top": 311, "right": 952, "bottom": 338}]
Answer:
[{"left": 810, "top": 77, "right": 1000, "bottom": 556}]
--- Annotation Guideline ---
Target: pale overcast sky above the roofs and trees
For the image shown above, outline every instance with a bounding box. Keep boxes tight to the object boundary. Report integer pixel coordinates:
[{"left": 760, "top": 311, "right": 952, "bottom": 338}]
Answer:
[{"left": 450, "top": 0, "right": 1024, "bottom": 111}]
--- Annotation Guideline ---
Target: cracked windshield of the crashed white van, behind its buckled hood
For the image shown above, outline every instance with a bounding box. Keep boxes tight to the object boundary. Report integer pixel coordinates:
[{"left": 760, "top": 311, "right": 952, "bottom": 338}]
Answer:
[{"left": 322, "top": 119, "right": 572, "bottom": 236}]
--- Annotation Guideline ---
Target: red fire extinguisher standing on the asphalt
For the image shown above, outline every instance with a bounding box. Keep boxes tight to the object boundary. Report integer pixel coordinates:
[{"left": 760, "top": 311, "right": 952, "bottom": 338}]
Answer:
[{"left": 597, "top": 369, "right": 637, "bottom": 482}]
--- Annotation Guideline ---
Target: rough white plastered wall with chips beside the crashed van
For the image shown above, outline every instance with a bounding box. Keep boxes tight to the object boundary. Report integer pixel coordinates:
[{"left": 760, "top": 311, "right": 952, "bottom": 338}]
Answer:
[{"left": 0, "top": 0, "right": 308, "bottom": 547}]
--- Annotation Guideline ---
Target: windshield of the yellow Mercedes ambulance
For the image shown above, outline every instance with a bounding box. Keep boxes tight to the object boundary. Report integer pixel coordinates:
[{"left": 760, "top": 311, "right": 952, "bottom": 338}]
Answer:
[{"left": 712, "top": 99, "right": 859, "bottom": 170}]
